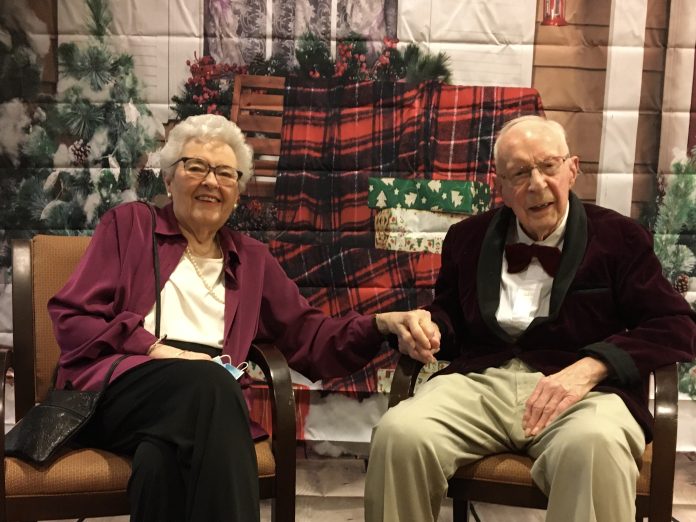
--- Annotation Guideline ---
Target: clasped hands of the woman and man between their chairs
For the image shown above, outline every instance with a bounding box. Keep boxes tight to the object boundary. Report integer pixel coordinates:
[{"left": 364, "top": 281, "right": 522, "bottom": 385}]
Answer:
[{"left": 375, "top": 310, "right": 440, "bottom": 364}]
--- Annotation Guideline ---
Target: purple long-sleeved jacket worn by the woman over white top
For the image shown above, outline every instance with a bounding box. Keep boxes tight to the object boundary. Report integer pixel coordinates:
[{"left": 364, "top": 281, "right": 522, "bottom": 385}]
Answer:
[{"left": 48, "top": 203, "right": 383, "bottom": 432}]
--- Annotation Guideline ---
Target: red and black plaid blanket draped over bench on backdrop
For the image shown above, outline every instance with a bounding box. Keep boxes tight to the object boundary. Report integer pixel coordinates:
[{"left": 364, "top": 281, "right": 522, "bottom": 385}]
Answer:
[{"left": 270, "top": 78, "right": 543, "bottom": 391}]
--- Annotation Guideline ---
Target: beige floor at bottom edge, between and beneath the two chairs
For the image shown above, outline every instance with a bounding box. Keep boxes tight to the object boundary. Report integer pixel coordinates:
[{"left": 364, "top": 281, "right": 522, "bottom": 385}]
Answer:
[{"left": 49, "top": 453, "right": 696, "bottom": 522}]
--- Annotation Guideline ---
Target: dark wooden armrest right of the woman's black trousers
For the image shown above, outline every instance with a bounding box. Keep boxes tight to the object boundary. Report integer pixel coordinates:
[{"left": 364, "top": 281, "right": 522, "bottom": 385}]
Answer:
[{"left": 249, "top": 343, "right": 296, "bottom": 472}]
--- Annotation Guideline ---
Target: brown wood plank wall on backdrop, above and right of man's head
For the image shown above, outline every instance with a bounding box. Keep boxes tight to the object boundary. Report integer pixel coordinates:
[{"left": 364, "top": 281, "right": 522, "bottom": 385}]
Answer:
[{"left": 532, "top": 0, "right": 669, "bottom": 217}]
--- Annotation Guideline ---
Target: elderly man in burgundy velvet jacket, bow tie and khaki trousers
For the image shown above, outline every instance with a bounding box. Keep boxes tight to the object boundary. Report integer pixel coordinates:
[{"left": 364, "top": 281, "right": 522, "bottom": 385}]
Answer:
[{"left": 365, "top": 116, "right": 696, "bottom": 522}]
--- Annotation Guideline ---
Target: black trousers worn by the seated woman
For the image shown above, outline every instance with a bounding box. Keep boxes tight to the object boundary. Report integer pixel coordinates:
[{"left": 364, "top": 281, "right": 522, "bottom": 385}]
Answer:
[{"left": 77, "top": 359, "right": 260, "bottom": 522}]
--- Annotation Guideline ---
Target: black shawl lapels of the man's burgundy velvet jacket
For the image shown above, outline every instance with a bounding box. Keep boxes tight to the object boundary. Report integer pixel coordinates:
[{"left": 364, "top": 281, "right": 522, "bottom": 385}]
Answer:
[{"left": 476, "top": 192, "right": 587, "bottom": 343}]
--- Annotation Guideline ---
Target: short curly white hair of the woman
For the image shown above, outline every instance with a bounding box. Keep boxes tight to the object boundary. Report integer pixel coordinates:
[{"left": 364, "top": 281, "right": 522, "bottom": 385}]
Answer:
[{"left": 160, "top": 114, "right": 254, "bottom": 192}]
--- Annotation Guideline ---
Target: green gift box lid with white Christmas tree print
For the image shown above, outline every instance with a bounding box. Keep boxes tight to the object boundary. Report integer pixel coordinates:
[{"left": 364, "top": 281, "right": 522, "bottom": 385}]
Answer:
[{"left": 367, "top": 178, "right": 491, "bottom": 214}]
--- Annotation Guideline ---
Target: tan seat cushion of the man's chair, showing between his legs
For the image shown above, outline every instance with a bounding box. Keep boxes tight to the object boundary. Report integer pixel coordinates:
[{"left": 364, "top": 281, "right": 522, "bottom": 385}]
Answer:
[{"left": 452, "top": 444, "right": 652, "bottom": 495}]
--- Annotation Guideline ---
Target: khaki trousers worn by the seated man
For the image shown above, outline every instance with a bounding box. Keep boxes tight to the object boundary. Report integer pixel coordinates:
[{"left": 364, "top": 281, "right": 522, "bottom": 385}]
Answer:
[{"left": 365, "top": 359, "right": 645, "bottom": 522}]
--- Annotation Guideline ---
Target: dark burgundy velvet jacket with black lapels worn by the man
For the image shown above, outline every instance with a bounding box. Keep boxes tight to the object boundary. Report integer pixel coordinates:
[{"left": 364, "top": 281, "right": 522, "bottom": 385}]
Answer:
[{"left": 429, "top": 193, "right": 696, "bottom": 441}]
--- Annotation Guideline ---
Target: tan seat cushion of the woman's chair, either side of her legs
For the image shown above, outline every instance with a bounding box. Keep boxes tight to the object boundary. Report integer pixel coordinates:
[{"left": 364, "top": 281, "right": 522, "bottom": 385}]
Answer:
[{"left": 5, "top": 439, "right": 275, "bottom": 497}]
